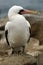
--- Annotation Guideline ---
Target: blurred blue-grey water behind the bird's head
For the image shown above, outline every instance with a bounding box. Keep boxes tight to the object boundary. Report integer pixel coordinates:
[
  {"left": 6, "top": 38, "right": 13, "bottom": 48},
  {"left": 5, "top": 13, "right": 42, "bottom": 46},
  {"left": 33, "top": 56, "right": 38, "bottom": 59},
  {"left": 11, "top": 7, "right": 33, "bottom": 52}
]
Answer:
[{"left": 0, "top": 0, "right": 43, "bottom": 19}]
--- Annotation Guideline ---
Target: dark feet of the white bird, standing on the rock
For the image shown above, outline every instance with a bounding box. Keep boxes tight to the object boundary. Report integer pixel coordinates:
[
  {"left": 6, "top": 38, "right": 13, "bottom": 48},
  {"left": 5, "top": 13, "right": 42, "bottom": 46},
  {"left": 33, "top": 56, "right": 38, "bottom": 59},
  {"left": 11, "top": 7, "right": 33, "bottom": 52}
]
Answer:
[{"left": 8, "top": 46, "right": 25, "bottom": 56}]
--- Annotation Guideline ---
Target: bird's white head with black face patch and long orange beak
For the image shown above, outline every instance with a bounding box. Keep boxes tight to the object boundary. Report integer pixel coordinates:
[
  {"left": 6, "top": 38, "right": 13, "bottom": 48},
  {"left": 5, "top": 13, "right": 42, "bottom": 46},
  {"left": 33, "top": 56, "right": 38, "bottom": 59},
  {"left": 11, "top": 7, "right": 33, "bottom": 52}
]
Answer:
[{"left": 8, "top": 5, "right": 37, "bottom": 18}]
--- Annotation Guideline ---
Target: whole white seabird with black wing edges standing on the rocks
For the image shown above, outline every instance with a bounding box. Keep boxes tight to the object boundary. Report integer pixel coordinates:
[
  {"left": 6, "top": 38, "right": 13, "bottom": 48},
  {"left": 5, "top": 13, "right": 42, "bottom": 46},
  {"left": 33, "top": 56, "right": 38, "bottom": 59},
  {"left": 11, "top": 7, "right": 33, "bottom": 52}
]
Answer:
[{"left": 5, "top": 5, "right": 35, "bottom": 53}]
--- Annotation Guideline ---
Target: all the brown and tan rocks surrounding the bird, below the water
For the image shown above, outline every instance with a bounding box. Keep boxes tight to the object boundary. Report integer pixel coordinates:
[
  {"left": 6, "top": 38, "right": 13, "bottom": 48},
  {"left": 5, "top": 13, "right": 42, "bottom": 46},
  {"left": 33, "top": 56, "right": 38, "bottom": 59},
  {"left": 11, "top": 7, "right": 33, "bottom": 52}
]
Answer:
[{"left": 0, "top": 13, "right": 43, "bottom": 65}]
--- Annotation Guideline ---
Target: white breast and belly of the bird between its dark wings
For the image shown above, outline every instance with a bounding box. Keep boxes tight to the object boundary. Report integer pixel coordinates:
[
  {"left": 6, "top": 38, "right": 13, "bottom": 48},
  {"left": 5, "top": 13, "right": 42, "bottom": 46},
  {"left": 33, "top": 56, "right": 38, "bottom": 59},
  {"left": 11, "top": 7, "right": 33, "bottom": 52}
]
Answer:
[{"left": 8, "top": 19, "right": 30, "bottom": 46}]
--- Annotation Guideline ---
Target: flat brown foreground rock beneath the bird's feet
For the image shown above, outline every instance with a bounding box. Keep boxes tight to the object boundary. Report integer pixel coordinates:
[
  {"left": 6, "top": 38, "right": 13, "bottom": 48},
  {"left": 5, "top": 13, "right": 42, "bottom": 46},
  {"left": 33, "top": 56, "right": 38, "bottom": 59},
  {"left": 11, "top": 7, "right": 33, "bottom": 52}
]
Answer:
[{"left": 0, "top": 55, "right": 36, "bottom": 65}]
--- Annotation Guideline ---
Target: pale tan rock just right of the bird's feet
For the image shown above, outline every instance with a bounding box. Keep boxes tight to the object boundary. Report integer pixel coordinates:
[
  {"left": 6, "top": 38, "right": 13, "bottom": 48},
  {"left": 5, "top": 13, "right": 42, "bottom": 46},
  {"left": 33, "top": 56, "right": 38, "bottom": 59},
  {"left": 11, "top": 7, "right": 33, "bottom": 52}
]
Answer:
[{"left": 25, "top": 38, "right": 40, "bottom": 57}]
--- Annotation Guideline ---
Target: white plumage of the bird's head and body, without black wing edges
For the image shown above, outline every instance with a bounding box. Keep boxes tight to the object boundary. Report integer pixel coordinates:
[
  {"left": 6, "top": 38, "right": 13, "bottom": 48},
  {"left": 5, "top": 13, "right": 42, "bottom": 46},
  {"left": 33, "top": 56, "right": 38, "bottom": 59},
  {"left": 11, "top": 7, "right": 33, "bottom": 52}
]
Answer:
[{"left": 5, "top": 6, "right": 31, "bottom": 47}]
